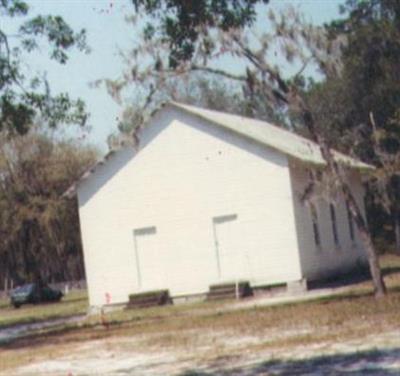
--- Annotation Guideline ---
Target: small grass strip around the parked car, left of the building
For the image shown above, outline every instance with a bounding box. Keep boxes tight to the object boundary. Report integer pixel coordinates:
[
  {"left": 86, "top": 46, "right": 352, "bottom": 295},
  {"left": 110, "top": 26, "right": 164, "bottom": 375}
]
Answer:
[{"left": 0, "top": 290, "right": 88, "bottom": 330}]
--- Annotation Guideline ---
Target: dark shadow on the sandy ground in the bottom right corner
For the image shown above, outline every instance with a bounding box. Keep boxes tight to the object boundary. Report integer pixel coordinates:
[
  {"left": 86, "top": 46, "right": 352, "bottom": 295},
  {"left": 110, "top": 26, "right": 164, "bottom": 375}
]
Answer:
[{"left": 180, "top": 348, "right": 400, "bottom": 376}]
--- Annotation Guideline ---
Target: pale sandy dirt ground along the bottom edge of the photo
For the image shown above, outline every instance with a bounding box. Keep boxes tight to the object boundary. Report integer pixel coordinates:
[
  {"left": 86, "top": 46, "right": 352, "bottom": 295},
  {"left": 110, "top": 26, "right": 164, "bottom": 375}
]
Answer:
[{"left": 6, "top": 328, "right": 400, "bottom": 376}]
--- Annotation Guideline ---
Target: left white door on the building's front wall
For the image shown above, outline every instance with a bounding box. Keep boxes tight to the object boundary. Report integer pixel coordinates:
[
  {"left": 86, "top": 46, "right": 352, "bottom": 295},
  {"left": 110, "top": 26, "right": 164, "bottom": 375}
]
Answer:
[{"left": 133, "top": 227, "right": 165, "bottom": 291}]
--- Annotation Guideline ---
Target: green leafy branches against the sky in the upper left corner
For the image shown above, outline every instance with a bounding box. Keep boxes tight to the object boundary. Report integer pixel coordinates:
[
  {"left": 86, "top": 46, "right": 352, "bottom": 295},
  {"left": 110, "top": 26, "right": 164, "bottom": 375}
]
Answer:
[{"left": 0, "top": 0, "right": 88, "bottom": 134}]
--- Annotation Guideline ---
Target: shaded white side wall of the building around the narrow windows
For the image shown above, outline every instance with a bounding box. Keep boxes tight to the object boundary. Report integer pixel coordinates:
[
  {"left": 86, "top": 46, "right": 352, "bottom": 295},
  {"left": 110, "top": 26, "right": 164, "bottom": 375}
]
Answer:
[{"left": 290, "top": 161, "right": 366, "bottom": 280}]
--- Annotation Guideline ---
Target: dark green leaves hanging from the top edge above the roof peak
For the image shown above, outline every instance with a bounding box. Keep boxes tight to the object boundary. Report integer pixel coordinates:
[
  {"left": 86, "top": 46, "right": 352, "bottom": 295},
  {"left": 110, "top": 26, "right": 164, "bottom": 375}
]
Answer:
[{"left": 132, "top": 0, "right": 269, "bottom": 69}]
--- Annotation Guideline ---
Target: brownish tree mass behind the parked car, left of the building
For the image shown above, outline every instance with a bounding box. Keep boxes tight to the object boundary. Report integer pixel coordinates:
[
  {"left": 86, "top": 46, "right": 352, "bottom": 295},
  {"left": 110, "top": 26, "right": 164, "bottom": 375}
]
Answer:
[{"left": 0, "top": 129, "right": 97, "bottom": 281}]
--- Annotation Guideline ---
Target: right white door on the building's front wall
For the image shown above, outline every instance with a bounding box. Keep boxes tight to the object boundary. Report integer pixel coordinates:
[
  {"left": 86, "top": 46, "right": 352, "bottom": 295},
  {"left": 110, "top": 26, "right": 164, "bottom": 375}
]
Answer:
[{"left": 213, "top": 214, "right": 246, "bottom": 282}]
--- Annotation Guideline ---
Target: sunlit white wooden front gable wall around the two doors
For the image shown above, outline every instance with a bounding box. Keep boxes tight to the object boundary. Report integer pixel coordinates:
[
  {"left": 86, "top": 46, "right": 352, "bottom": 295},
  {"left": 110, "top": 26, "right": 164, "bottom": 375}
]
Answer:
[{"left": 78, "top": 109, "right": 301, "bottom": 305}]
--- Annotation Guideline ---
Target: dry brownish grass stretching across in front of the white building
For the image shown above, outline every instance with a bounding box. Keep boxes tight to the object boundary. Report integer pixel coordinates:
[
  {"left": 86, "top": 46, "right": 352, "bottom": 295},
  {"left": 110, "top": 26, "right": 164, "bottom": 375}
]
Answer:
[{"left": 0, "top": 256, "right": 400, "bottom": 369}]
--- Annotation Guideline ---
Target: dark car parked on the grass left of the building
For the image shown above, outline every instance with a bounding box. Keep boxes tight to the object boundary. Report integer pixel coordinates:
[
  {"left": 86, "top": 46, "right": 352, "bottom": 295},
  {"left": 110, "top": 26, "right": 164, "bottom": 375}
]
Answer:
[{"left": 11, "top": 283, "right": 63, "bottom": 308}]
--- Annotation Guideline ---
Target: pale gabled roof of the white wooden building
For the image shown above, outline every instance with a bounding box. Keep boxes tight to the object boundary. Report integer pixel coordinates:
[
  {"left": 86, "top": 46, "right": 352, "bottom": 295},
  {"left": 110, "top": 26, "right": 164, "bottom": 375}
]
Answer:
[{"left": 64, "top": 102, "right": 374, "bottom": 197}]
